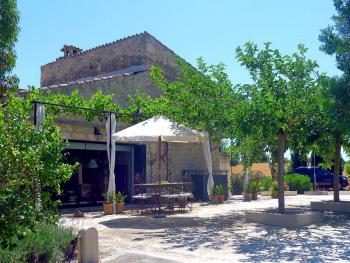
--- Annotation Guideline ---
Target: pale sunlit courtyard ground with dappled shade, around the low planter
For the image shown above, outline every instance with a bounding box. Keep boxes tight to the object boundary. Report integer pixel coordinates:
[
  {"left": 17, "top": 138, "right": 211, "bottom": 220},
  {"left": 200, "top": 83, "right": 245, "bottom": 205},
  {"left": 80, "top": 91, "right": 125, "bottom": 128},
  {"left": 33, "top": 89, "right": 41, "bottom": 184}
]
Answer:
[{"left": 63, "top": 195, "right": 350, "bottom": 263}]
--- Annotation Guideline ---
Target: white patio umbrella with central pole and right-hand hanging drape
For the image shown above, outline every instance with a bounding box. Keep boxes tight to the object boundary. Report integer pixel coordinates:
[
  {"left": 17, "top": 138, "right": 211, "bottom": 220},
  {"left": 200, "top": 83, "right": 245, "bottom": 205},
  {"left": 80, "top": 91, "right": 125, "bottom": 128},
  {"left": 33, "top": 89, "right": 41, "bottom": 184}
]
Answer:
[{"left": 112, "top": 115, "right": 214, "bottom": 194}]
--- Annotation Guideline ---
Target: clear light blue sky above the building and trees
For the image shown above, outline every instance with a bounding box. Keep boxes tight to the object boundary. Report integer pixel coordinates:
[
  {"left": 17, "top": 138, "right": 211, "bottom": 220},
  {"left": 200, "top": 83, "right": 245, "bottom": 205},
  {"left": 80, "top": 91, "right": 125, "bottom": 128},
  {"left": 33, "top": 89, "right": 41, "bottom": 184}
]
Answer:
[{"left": 14, "top": 0, "right": 337, "bottom": 88}]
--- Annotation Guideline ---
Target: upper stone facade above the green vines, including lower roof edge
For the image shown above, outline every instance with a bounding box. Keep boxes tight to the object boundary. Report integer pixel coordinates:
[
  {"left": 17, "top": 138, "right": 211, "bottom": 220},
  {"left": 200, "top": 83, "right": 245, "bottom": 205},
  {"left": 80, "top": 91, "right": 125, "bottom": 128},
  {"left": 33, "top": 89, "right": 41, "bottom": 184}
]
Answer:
[{"left": 41, "top": 32, "right": 179, "bottom": 107}]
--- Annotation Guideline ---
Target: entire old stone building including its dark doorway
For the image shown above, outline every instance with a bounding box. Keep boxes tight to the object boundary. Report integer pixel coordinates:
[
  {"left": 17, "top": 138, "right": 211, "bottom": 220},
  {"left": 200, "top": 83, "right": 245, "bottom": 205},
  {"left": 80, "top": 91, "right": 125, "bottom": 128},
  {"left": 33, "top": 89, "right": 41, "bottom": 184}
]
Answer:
[{"left": 41, "top": 32, "right": 229, "bottom": 206}]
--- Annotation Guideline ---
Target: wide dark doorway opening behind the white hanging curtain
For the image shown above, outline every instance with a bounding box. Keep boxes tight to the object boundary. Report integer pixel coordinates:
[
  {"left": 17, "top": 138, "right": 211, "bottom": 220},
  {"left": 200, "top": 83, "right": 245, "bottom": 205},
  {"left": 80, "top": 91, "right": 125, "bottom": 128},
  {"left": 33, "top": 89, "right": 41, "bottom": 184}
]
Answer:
[{"left": 60, "top": 142, "right": 133, "bottom": 207}]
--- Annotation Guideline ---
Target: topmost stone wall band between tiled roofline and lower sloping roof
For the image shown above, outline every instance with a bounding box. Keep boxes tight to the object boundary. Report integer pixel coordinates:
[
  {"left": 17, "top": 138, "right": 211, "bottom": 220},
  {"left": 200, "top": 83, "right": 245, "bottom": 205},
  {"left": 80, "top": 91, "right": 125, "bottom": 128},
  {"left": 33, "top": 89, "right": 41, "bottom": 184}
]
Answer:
[{"left": 40, "top": 32, "right": 178, "bottom": 87}]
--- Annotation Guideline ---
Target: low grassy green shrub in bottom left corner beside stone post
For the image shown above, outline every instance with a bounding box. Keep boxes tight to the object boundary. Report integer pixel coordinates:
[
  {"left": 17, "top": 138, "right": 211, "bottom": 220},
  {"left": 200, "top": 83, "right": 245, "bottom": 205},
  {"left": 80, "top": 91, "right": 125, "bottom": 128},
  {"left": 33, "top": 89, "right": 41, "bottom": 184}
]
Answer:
[{"left": 0, "top": 224, "right": 75, "bottom": 263}]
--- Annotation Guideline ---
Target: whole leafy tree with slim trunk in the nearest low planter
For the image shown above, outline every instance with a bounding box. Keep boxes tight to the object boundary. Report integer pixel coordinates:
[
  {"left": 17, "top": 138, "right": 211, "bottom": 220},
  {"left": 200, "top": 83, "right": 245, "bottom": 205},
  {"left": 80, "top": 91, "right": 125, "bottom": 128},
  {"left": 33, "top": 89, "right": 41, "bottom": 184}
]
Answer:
[{"left": 235, "top": 42, "right": 318, "bottom": 213}]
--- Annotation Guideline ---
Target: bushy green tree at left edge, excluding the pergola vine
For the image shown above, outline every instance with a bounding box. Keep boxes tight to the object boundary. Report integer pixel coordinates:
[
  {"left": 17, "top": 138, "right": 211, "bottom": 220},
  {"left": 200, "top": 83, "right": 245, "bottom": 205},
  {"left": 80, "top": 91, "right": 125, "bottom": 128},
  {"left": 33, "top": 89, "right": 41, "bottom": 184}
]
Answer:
[{"left": 0, "top": 95, "right": 74, "bottom": 250}]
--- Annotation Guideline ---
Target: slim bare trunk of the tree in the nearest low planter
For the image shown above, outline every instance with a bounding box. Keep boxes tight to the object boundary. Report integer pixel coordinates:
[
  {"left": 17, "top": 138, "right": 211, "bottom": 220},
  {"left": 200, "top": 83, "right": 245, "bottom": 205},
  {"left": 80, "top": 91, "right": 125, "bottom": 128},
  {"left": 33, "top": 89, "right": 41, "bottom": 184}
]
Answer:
[{"left": 277, "top": 131, "right": 287, "bottom": 214}]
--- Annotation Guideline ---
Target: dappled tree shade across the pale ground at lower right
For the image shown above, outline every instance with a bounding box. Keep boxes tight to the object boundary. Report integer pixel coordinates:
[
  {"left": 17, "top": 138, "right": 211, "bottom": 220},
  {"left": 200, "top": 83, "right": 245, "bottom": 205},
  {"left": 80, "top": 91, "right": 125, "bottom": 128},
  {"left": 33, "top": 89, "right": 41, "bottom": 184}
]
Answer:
[{"left": 102, "top": 213, "right": 350, "bottom": 262}]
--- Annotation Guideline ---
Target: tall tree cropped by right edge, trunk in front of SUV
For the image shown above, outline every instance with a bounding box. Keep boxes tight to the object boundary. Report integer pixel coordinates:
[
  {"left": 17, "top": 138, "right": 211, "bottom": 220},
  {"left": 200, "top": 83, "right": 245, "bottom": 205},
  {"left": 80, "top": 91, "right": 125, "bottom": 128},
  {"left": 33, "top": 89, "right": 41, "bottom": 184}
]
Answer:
[{"left": 319, "top": 0, "right": 350, "bottom": 202}]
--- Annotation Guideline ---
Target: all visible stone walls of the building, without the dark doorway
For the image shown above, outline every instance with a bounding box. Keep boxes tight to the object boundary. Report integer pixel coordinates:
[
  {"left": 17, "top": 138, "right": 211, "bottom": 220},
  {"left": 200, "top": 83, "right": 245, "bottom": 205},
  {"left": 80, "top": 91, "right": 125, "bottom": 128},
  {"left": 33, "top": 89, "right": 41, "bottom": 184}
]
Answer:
[{"left": 41, "top": 32, "right": 228, "bottom": 188}]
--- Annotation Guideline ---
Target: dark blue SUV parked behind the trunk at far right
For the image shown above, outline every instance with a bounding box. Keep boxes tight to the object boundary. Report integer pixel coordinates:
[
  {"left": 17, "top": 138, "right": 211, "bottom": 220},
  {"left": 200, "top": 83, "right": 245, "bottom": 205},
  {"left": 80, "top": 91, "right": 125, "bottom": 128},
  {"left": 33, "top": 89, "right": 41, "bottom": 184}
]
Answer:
[{"left": 291, "top": 166, "right": 349, "bottom": 188}]
